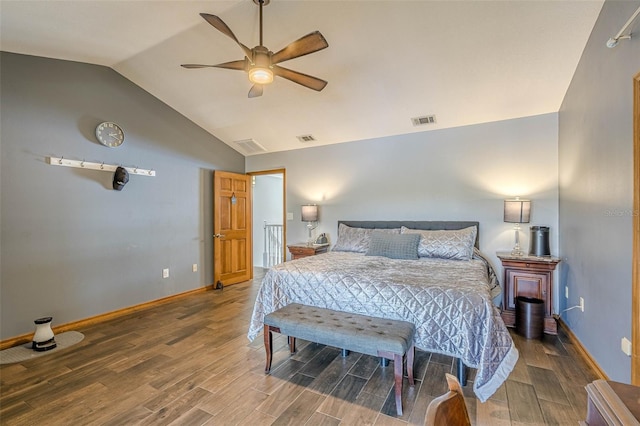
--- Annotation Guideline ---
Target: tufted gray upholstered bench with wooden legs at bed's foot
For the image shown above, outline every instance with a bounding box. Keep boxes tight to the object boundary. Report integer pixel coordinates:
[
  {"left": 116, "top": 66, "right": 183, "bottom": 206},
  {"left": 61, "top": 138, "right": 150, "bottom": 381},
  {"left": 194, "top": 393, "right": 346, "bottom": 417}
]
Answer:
[{"left": 264, "top": 303, "right": 415, "bottom": 416}]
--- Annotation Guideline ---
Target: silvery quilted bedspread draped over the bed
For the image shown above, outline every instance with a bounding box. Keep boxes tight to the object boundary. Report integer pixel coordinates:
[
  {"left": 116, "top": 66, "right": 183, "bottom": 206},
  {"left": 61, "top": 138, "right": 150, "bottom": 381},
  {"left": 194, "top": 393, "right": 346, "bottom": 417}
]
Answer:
[{"left": 248, "top": 252, "right": 518, "bottom": 402}]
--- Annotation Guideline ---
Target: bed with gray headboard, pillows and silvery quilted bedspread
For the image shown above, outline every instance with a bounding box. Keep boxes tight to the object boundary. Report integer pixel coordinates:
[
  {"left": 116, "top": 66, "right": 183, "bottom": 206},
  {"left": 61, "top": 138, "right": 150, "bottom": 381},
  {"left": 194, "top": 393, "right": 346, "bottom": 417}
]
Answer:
[{"left": 248, "top": 221, "right": 518, "bottom": 402}]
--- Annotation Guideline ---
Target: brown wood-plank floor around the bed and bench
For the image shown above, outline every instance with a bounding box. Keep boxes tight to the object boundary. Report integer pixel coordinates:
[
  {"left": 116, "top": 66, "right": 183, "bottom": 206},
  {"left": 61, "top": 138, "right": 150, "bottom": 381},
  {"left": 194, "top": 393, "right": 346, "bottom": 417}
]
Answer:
[{"left": 0, "top": 273, "right": 597, "bottom": 426}]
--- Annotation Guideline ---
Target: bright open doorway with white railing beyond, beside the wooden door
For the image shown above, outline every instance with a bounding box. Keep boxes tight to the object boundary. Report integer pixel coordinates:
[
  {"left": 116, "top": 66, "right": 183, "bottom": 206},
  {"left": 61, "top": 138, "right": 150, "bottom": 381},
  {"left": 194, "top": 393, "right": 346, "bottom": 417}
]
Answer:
[{"left": 248, "top": 169, "right": 287, "bottom": 269}]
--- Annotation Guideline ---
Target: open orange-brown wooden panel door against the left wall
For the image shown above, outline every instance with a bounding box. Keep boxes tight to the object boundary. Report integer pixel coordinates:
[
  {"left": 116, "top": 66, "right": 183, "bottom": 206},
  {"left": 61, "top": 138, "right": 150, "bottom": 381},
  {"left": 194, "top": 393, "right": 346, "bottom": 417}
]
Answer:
[{"left": 213, "top": 170, "right": 253, "bottom": 288}]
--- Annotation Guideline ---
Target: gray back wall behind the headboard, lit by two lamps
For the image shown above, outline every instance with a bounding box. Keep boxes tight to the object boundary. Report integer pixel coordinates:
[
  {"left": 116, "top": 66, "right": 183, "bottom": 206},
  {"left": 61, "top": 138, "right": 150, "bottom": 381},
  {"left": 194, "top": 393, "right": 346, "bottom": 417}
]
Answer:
[{"left": 246, "top": 114, "right": 558, "bottom": 299}]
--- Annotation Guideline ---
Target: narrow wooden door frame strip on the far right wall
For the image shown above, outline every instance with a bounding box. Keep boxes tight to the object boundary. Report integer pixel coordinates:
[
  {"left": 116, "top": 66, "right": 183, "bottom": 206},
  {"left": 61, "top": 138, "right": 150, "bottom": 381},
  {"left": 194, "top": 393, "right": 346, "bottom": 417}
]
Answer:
[{"left": 631, "top": 72, "right": 640, "bottom": 385}]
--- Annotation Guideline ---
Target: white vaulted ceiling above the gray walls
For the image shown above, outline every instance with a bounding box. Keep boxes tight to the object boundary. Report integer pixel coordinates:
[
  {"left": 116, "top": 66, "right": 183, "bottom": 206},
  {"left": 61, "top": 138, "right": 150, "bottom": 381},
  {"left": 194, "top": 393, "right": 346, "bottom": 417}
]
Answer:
[{"left": 0, "top": 0, "right": 604, "bottom": 154}]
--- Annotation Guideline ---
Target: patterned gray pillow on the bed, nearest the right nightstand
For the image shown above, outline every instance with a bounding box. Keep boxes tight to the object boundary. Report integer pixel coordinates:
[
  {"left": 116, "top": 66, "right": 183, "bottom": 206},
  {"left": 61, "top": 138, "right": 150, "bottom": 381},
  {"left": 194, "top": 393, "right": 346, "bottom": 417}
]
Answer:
[{"left": 400, "top": 226, "right": 478, "bottom": 260}]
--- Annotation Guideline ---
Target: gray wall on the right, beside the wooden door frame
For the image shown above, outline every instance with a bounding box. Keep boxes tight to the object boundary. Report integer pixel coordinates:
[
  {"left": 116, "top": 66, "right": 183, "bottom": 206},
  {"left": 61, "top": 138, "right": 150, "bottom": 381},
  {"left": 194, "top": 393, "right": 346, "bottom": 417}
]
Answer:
[{"left": 558, "top": 1, "right": 640, "bottom": 383}]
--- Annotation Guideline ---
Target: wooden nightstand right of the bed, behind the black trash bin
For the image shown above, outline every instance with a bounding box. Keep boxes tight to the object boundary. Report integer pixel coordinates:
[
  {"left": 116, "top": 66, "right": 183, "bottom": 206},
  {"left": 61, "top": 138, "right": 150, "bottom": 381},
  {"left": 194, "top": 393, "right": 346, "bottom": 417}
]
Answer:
[{"left": 496, "top": 252, "right": 560, "bottom": 334}]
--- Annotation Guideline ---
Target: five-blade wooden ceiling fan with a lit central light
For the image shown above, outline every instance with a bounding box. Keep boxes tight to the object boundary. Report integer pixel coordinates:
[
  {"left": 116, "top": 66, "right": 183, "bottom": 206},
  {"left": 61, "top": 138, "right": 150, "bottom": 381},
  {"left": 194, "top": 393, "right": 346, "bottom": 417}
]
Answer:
[{"left": 181, "top": 0, "right": 329, "bottom": 98}]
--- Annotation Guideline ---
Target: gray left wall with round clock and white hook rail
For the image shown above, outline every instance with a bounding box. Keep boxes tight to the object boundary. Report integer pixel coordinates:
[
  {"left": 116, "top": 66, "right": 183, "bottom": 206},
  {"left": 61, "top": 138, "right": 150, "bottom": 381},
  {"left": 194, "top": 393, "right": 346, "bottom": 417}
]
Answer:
[{"left": 0, "top": 53, "right": 244, "bottom": 339}]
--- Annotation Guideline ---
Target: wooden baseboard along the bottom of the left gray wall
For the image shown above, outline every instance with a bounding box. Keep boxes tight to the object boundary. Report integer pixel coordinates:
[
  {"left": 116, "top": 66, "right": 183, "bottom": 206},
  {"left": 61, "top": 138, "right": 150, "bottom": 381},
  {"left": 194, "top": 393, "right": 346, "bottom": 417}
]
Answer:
[{"left": 0, "top": 285, "right": 215, "bottom": 350}]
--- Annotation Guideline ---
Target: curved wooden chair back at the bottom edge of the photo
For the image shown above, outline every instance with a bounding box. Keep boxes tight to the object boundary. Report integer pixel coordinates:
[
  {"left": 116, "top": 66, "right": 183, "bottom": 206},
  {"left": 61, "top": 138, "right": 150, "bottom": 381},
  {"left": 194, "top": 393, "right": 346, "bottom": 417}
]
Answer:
[{"left": 424, "top": 374, "right": 471, "bottom": 426}]
